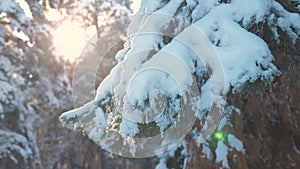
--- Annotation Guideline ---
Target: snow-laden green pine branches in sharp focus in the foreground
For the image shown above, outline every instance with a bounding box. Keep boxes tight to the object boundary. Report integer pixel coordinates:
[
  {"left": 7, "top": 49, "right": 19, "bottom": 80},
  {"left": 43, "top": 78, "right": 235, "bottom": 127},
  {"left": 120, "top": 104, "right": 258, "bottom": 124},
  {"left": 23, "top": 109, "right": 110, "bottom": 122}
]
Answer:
[{"left": 60, "top": 0, "right": 300, "bottom": 168}]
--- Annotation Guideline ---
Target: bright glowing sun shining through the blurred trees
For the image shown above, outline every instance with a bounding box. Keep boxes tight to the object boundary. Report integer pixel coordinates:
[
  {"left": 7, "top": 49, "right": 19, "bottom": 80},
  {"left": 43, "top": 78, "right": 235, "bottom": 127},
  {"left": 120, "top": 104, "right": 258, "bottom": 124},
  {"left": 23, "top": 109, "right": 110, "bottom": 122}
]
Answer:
[{"left": 53, "top": 20, "right": 86, "bottom": 62}]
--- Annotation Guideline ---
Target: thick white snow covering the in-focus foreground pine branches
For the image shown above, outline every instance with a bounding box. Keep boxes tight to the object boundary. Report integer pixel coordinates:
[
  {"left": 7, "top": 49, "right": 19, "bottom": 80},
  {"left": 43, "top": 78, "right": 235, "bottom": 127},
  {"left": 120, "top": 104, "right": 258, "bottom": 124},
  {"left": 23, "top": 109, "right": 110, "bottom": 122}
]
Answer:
[{"left": 61, "top": 0, "right": 300, "bottom": 160}]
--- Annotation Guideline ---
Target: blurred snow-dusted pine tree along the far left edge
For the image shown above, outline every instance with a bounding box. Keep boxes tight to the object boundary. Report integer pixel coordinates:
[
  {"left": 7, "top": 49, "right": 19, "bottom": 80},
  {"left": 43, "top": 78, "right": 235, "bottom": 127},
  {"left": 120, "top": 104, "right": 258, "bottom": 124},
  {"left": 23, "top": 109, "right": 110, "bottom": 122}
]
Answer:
[{"left": 0, "top": 0, "right": 70, "bottom": 168}]
